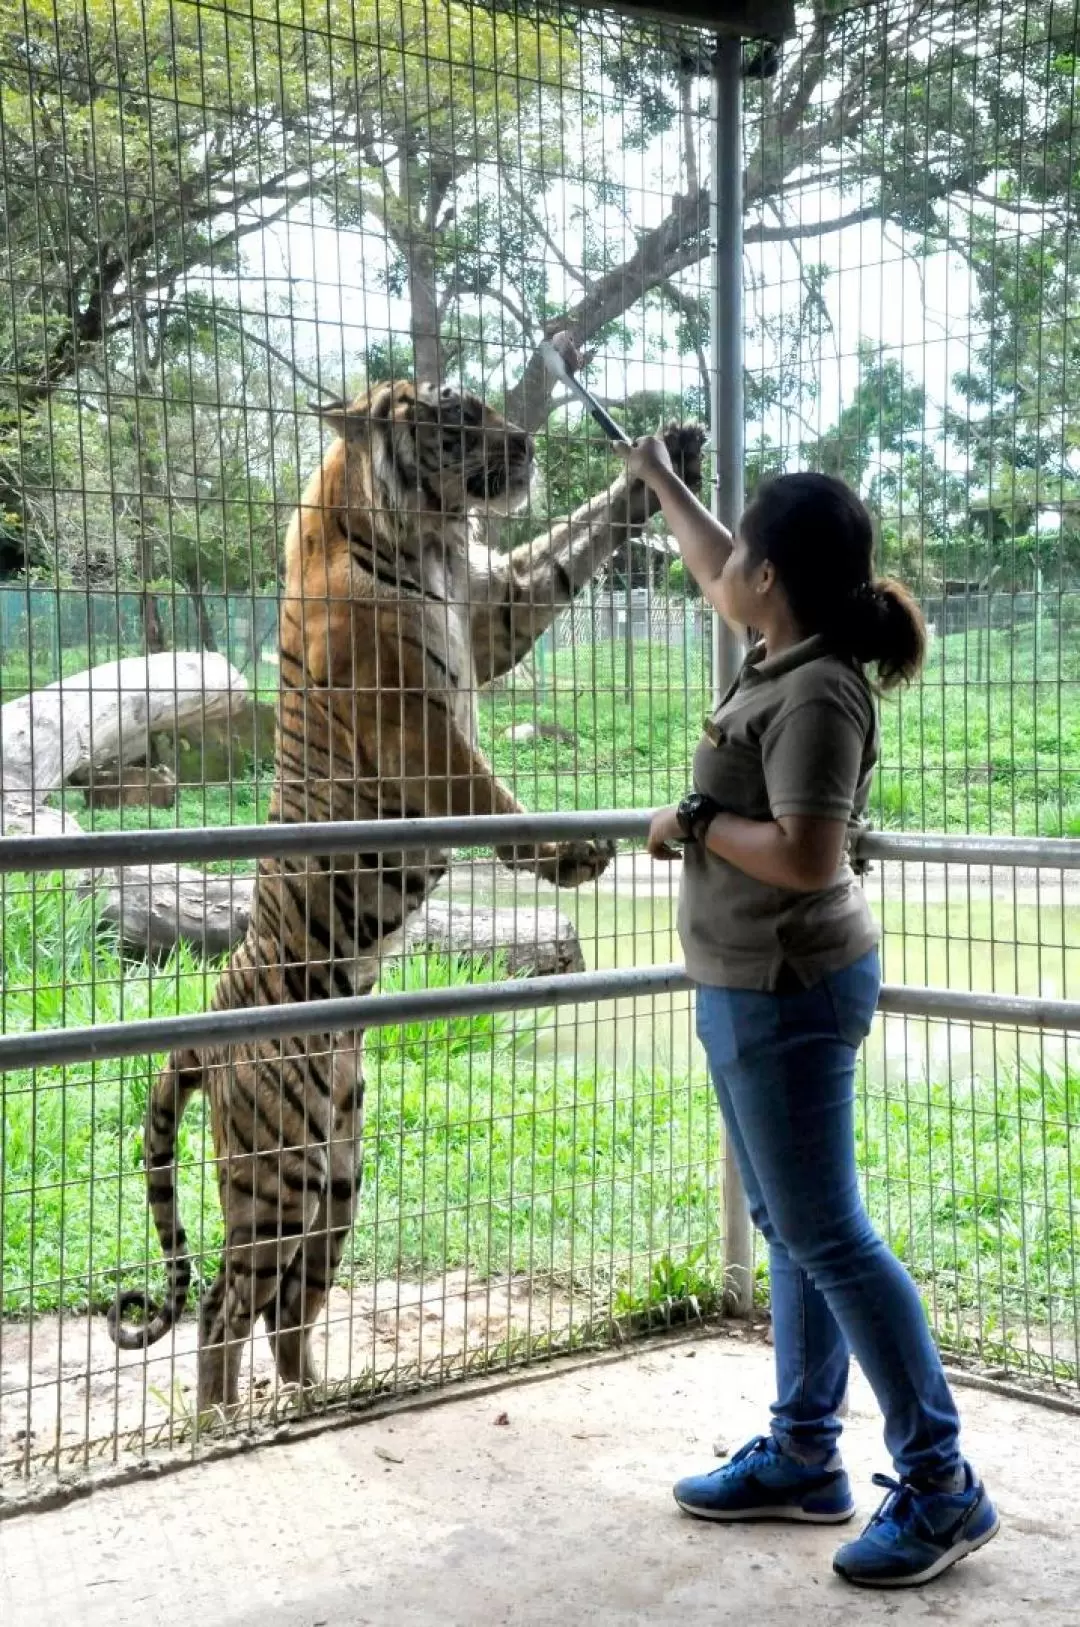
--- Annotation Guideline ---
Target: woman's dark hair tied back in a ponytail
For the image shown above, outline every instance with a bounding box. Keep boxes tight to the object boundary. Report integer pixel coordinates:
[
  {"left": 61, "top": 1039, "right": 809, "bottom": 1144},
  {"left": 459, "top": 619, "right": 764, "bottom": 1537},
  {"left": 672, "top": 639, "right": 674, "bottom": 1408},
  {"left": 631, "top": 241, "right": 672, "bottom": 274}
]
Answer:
[{"left": 738, "top": 473, "right": 925, "bottom": 690}]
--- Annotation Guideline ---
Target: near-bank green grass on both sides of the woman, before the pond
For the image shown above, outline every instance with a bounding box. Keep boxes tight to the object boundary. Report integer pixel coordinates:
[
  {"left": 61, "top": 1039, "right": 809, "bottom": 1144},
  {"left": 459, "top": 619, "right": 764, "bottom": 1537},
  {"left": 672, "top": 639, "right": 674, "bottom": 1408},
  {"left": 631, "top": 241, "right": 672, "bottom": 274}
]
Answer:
[{"left": 0, "top": 877, "right": 1080, "bottom": 1373}]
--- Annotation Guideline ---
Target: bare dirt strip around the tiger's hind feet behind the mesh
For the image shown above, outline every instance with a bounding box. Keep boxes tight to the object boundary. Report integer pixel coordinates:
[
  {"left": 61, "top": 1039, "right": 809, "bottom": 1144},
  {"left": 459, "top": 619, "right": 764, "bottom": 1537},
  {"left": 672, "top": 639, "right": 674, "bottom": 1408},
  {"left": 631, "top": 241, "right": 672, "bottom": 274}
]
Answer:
[{"left": 0, "top": 1271, "right": 584, "bottom": 1482}]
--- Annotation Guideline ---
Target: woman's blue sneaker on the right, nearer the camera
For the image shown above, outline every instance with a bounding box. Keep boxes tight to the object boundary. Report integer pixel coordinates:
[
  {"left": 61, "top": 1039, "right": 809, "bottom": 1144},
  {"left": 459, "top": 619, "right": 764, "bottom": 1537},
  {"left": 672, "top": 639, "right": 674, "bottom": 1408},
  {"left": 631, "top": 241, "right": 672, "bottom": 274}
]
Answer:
[{"left": 833, "top": 1464, "right": 999, "bottom": 1588}]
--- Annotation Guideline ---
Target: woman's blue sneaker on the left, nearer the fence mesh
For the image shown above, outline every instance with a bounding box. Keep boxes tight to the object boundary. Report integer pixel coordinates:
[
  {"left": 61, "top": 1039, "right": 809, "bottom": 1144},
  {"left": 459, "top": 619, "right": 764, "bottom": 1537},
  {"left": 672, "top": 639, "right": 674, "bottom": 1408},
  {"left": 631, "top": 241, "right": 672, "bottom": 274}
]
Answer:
[{"left": 675, "top": 1435, "right": 856, "bottom": 1524}]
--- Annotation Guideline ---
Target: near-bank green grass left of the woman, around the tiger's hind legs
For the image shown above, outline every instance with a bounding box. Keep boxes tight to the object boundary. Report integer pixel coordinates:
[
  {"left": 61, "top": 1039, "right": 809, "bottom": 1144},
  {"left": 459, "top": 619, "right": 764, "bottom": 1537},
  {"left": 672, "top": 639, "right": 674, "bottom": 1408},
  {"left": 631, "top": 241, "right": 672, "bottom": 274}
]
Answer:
[{"left": 0, "top": 898, "right": 716, "bottom": 1315}]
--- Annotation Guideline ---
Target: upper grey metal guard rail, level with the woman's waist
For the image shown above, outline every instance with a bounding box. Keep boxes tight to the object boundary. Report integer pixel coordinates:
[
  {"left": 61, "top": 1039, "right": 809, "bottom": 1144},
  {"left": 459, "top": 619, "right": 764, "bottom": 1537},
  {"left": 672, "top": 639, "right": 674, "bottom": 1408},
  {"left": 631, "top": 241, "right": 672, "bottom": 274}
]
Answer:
[{"left": 0, "top": 809, "right": 1080, "bottom": 872}]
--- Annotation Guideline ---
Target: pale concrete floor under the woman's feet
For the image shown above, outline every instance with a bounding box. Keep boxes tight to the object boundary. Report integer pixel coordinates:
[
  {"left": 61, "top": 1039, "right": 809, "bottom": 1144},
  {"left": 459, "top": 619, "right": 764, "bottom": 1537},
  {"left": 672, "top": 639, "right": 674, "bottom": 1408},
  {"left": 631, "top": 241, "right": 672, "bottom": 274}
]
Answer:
[{"left": 0, "top": 1339, "right": 1080, "bottom": 1627}]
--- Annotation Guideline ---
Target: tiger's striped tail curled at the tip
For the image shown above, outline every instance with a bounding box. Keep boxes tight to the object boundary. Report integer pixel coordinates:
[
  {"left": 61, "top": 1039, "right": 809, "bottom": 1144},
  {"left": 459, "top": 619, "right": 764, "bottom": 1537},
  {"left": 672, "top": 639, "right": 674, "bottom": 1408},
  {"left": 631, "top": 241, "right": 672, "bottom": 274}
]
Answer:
[{"left": 106, "top": 1051, "right": 205, "bottom": 1350}]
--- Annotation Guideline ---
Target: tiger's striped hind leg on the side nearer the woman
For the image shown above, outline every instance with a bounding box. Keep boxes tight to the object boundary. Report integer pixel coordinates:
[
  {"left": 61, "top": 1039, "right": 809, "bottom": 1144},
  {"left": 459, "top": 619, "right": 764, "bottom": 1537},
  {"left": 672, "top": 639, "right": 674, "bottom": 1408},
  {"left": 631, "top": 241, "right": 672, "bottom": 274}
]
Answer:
[{"left": 262, "top": 1035, "right": 364, "bottom": 1385}]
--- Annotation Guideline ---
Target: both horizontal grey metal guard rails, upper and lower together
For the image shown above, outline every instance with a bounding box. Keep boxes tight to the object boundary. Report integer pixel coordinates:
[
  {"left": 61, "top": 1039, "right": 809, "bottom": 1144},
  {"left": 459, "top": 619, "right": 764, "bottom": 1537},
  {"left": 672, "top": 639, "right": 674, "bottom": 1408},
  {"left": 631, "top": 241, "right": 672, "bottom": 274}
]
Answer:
[{"left": 0, "top": 809, "right": 1080, "bottom": 1080}]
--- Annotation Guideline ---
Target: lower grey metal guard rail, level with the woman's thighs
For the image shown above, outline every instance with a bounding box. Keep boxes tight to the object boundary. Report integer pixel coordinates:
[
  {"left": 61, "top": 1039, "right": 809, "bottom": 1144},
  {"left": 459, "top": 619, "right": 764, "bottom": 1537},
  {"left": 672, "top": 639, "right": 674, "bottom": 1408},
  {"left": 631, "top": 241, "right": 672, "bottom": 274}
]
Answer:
[{"left": 0, "top": 963, "right": 1080, "bottom": 1074}]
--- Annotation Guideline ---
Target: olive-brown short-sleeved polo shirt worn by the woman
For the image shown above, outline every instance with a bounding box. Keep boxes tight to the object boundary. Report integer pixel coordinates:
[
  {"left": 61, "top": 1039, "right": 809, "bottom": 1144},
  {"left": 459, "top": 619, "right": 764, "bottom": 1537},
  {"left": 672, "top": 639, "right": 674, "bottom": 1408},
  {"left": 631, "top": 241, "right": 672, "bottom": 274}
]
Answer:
[{"left": 678, "top": 638, "right": 880, "bottom": 989}]
